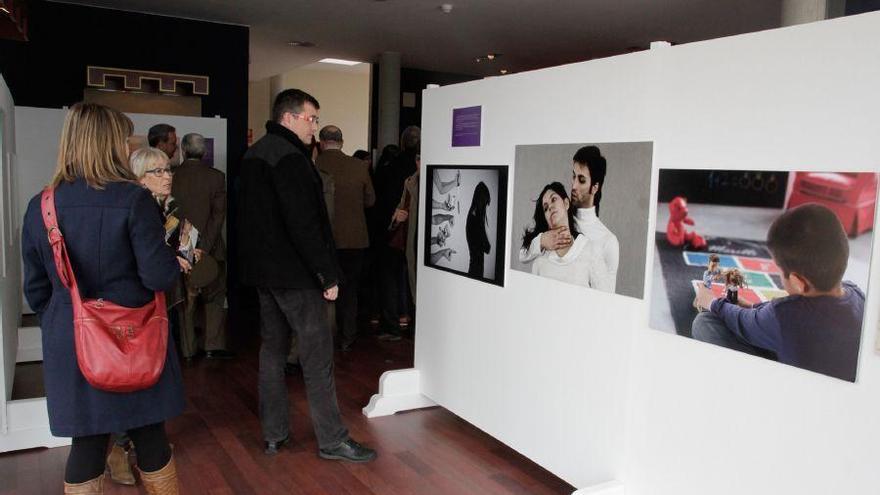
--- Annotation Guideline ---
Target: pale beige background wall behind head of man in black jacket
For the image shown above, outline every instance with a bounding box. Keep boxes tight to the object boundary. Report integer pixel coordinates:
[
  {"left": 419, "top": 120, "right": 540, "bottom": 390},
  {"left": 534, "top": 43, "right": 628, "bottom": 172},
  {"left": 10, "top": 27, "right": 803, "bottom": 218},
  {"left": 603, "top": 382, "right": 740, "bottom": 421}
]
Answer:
[{"left": 248, "top": 64, "right": 370, "bottom": 155}]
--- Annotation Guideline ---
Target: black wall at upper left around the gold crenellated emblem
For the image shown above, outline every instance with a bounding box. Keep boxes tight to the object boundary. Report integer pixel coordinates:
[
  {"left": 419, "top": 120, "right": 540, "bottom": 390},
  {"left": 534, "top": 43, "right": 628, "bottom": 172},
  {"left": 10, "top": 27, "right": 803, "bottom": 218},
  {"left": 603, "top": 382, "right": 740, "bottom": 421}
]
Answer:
[{"left": 0, "top": 0, "right": 249, "bottom": 316}]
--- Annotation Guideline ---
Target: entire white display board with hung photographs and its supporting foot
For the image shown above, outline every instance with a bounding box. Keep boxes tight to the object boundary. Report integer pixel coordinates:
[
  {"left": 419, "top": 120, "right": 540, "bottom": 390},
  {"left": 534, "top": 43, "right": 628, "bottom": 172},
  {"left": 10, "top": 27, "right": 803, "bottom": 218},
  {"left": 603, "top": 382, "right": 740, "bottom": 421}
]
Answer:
[{"left": 365, "top": 9, "right": 880, "bottom": 495}]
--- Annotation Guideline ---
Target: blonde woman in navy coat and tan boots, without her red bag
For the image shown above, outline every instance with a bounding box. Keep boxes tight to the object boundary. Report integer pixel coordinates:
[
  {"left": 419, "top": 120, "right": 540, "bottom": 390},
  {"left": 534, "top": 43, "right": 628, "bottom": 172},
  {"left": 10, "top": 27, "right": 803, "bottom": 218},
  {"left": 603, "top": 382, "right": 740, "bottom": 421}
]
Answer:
[{"left": 22, "top": 103, "right": 184, "bottom": 494}]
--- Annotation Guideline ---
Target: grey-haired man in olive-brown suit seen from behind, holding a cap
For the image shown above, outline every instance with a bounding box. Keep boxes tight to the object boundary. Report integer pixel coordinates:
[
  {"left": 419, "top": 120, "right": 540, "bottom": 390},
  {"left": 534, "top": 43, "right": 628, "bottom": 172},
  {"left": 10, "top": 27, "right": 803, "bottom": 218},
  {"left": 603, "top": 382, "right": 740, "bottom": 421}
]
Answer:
[{"left": 171, "top": 133, "right": 233, "bottom": 359}]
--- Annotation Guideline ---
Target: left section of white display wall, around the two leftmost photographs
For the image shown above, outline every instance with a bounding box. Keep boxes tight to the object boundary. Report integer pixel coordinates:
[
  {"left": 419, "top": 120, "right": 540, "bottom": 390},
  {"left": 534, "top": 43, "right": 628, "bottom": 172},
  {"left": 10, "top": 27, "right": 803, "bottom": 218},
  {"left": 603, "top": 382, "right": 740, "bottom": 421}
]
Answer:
[{"left": 415, "top": 53, "right": 653, "bottom": 486}]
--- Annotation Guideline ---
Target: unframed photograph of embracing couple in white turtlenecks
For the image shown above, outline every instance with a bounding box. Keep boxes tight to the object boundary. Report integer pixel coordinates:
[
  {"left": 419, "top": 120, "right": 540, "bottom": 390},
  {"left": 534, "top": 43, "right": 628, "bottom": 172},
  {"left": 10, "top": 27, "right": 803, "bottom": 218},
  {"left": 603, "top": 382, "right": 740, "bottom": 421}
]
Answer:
[{"left": 510, "top": 142, "right": 652, "bottom": 299}]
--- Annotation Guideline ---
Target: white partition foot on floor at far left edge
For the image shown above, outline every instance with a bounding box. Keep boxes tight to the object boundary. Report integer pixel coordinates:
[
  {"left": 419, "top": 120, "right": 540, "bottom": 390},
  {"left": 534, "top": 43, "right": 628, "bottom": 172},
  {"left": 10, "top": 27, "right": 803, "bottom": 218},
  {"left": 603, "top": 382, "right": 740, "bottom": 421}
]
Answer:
[{"left": 0, "top": 397, "right": 70, "bottom": 452}]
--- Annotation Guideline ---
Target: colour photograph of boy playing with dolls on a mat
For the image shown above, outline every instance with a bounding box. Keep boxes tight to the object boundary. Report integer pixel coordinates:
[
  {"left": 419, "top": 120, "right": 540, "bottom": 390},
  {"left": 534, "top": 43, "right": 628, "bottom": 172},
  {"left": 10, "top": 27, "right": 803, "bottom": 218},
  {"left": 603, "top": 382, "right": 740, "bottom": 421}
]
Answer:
[{"left": 650, "top": 169, "right": 880, "bottom": 382}]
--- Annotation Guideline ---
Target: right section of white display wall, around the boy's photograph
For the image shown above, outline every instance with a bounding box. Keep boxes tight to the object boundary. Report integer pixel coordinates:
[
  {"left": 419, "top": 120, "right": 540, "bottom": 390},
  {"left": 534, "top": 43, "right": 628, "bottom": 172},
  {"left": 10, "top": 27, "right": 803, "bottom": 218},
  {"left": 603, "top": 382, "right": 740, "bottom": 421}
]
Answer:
[{"left": 626, "top": 14, "right": 880, "bottom": 495}]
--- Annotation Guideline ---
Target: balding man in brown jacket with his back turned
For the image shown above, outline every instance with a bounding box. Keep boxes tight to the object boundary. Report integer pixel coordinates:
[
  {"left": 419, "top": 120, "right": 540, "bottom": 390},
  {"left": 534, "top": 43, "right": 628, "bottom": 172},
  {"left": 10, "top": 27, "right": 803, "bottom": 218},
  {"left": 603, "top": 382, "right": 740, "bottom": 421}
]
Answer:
[{"left": 316, "top": 125, "right": 376, "bottom": 351}]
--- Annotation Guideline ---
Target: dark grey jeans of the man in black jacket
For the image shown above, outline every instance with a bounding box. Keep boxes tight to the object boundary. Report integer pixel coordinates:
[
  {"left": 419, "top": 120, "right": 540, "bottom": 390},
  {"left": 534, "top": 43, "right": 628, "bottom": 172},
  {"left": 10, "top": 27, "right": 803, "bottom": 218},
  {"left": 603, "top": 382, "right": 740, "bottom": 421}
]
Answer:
[{"left": 258, "top": 289, "right": 348, "bottom": 449}]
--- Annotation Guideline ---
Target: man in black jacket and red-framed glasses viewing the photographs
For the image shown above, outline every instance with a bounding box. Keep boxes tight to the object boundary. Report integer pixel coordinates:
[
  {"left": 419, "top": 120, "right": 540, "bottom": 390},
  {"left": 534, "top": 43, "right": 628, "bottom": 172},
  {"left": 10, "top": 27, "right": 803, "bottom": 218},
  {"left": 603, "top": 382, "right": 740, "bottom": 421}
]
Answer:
[{"left": 238, "top": 89, "right": 376, "bottom": 462}]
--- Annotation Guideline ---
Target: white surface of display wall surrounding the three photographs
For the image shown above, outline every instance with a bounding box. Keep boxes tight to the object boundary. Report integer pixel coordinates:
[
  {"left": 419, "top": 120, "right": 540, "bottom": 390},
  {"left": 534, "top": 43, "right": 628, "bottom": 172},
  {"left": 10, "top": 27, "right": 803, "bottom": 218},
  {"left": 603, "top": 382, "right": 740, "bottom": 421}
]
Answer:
[{"left": 415, "top": 9, "right": 880, "bottom": 495}]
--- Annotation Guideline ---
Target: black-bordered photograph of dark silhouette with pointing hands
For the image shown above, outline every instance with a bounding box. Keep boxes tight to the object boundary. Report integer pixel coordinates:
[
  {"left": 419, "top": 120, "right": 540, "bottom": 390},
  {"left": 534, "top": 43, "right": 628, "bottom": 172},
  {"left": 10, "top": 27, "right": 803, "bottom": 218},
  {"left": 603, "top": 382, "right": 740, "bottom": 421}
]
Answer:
[{"left": 423, "top": 165, "right": 508, "bottom": 287}]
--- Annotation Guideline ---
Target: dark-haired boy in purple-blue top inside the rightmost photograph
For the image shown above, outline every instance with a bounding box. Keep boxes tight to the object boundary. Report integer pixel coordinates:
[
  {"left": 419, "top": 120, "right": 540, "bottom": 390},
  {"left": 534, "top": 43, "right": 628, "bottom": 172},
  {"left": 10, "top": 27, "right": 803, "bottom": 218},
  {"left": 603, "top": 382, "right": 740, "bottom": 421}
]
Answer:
[{"left": 692, "top": 204, "right": 865, "bottom": 382}]
